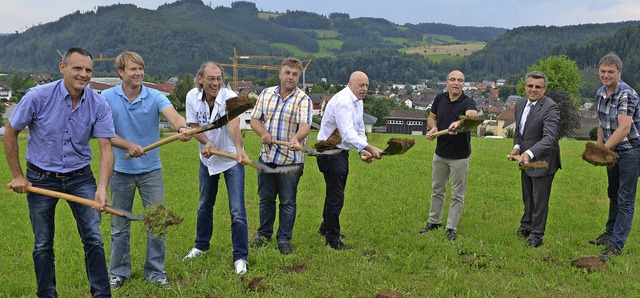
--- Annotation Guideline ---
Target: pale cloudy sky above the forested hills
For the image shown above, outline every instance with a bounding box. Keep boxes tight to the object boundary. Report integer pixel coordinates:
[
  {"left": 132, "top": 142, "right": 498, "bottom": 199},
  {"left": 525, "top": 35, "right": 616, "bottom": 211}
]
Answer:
[{"left": 0, "top": 0, "right": 640, "bottom": 33}]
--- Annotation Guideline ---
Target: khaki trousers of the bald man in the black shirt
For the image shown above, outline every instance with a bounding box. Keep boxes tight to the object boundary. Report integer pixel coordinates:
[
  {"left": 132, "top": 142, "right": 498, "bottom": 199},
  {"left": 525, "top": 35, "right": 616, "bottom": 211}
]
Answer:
[{"left": 428, "top": 154, "right": 469, "bottom": 231}]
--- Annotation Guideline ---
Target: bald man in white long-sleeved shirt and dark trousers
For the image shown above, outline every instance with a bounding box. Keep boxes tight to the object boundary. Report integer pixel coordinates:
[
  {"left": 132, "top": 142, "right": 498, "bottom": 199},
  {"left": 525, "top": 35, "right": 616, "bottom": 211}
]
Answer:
[{"left": 318, "top": 71, "right": 382, "bottom": 250}]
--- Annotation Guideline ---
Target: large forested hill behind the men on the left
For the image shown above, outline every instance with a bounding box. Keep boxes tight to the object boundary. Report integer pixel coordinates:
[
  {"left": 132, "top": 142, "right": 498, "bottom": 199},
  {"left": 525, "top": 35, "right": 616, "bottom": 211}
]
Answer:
[{"left": 0, "top": 0, "right": 505, "bottom": 74}]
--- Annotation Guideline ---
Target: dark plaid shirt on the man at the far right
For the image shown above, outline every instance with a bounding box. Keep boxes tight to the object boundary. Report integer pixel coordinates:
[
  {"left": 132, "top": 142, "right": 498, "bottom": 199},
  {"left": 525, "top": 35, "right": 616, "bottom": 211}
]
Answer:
[{"left": 596, "top": 81, "right": 640, "bottom": 152}]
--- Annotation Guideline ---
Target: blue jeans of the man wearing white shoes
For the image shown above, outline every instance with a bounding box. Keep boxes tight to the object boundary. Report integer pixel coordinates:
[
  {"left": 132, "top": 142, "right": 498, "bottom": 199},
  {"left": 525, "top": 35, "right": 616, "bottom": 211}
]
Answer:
[{"left": 195, "top": 162, "right": 249, "bottom": 262}]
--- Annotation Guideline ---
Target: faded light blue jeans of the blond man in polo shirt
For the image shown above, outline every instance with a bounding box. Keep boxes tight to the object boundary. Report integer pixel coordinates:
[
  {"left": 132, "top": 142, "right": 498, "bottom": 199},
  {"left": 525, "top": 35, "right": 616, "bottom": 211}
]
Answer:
[{"left": 109, "top": 169, "right": 167, "bottom": 282}]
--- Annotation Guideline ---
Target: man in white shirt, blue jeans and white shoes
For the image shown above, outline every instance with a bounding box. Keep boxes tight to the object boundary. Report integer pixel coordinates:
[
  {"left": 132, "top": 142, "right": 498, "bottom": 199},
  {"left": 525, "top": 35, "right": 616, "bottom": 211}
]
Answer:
[{"left": 183, "top": 61, "right": 249, "bottom": 275}]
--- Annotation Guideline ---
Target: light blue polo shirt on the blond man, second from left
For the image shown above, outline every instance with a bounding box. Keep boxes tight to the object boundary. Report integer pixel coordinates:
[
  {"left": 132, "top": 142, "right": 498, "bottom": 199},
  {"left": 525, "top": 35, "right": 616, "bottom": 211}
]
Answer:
[{"left": 102, "top": 85, "right": 173, "bottom": 174}]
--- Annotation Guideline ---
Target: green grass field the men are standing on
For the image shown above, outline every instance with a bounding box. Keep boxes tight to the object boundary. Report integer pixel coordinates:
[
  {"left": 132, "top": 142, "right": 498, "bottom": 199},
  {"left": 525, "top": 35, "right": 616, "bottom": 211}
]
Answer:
[{"left": 0, "top": 132, "right": 640, "bottom": 297}]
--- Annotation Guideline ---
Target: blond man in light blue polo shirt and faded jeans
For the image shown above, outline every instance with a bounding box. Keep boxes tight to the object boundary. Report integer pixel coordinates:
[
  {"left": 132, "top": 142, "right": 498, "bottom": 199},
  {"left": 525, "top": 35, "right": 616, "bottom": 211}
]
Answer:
[{"left": 102, "top": 52, "right": 189, "bottom": 289}]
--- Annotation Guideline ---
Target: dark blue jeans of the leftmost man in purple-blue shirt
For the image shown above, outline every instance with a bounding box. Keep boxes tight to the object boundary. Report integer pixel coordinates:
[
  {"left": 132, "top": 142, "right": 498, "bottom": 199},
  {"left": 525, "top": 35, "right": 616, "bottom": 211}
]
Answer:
[{"left": 27, "top": 167, "right": 111, "bottom": 297}]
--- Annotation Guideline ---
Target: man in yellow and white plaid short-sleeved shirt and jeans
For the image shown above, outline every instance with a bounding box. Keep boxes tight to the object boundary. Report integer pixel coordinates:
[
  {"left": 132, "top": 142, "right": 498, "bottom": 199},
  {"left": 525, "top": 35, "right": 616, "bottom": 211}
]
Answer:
[{"left": 251, "top": 58, "right": 312, "bottom": 255}]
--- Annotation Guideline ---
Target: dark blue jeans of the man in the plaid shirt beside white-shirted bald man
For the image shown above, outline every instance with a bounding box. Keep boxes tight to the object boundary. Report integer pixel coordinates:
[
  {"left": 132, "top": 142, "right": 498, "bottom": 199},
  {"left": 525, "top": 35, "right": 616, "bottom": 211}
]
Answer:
[{"left": 258, "top": 160, "right": 304, "bottom": 243}]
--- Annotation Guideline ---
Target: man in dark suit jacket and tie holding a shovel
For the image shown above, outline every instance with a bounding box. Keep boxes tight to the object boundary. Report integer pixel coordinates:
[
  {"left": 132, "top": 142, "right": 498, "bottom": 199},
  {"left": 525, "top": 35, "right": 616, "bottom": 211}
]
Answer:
[{"left": 509, "top": 71, "right": 561, "bottom": 247}]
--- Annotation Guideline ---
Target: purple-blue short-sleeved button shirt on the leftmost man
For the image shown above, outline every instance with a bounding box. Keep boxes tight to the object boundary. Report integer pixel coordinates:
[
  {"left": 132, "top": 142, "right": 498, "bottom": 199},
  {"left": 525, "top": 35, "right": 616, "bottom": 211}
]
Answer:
[{"left": 9, "top": 80, "right": 115, "bottom": 173}]
